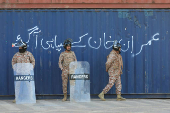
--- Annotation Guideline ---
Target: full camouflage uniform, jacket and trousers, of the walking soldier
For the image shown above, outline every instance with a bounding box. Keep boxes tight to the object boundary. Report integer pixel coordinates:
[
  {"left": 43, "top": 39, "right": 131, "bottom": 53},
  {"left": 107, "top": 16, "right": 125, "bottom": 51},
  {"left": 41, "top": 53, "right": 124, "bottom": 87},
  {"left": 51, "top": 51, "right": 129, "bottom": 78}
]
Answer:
[{"left": 103, "top": 50, "right": 123, "bottom": 95}]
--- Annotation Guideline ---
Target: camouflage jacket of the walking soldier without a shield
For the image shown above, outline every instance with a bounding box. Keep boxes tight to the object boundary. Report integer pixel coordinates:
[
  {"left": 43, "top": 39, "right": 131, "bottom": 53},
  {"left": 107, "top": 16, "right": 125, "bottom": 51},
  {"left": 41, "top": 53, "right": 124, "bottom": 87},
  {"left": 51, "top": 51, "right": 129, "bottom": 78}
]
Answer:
[{"left": 106, "top": 50, "right": 123, "bottom": 74}]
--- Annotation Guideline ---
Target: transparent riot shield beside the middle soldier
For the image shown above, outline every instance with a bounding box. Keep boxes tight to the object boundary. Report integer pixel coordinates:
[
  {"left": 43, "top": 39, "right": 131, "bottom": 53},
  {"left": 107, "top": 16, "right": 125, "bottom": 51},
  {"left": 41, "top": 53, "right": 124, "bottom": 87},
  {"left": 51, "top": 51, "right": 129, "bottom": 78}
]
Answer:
[{"left": 69, "top": 61, "right": 90, "bottom": 102}]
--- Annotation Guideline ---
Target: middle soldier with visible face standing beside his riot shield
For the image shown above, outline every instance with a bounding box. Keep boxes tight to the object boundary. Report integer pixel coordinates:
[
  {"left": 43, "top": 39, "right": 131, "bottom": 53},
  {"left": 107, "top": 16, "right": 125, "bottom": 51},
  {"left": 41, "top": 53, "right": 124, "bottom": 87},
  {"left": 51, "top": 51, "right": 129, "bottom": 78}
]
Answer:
[{"left": 58, "top": 40, "right": 77, "bottom": 101}]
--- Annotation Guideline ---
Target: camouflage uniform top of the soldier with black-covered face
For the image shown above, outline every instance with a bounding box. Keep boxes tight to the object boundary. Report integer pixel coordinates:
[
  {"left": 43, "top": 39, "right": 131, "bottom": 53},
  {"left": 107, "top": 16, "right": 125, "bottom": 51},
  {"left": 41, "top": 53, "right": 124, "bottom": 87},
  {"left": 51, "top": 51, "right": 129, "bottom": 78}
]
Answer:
[{"left": 12, "top": 51, "right": 35, "bottom": 67}]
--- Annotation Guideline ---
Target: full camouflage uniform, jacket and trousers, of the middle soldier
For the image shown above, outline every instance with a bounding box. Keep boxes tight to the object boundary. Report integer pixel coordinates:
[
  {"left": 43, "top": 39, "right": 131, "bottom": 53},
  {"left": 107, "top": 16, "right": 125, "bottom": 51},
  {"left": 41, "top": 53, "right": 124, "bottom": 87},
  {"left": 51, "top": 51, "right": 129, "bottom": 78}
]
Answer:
[{"left": 58, "top": 51, "right": 77, "bottom": 93}]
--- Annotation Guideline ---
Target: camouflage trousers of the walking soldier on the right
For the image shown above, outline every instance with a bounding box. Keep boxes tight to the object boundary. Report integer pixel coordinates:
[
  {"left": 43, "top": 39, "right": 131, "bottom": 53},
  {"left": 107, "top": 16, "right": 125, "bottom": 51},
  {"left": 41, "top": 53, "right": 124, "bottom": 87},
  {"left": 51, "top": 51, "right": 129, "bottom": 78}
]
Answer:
[{"left": 103, "top": 72, "right": 122, "bottom": 95}]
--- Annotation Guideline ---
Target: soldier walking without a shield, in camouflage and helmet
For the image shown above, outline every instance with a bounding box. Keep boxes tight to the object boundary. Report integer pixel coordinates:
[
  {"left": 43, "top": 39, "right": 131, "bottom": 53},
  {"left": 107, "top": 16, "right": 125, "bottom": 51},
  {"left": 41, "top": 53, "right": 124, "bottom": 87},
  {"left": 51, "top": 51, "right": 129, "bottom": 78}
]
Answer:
[{"left": 98, "top": 41, "right": 125, "bottom": 101}]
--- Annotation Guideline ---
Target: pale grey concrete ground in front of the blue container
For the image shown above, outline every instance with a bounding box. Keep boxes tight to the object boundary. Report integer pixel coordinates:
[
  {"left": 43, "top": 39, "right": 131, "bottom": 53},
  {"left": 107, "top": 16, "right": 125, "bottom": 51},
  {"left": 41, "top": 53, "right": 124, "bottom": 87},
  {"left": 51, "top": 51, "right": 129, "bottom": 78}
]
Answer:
[{"left": 0, "top": 99, "right": 170, "bottom": 113}]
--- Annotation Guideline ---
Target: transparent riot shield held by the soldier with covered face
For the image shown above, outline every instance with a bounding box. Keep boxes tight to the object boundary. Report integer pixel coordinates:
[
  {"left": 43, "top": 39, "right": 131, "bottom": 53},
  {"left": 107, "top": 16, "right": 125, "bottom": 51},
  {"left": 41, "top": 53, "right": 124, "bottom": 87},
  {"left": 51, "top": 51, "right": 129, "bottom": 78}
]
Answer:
[{"left": 13, "top": 63, "right": 36, "bottom": 104}]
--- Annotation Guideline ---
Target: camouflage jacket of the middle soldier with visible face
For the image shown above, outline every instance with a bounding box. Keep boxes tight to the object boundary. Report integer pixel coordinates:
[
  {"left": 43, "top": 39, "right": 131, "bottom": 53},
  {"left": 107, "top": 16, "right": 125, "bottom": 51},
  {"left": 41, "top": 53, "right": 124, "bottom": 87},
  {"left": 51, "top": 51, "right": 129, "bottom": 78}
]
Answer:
[{"left": 58, "top": 51, "right": 77, "bottom": 70}]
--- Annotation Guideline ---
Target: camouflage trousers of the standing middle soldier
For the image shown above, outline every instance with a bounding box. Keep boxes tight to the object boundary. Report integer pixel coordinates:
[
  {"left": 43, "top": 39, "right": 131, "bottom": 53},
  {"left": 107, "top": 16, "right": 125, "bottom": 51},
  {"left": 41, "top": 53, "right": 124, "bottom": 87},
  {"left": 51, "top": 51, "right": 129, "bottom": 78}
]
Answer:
[{"left": 61, "top": 69, "right": 69, "bottom": 93}]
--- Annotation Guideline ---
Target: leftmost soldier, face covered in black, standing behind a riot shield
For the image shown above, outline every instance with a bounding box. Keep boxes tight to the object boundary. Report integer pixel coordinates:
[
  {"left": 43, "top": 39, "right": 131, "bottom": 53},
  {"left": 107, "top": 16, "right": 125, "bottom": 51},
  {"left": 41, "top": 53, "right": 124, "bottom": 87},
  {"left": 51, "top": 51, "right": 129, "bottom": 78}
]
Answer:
[{"left": 12, "top": 41, "right": 35, "bottom": 103}]
